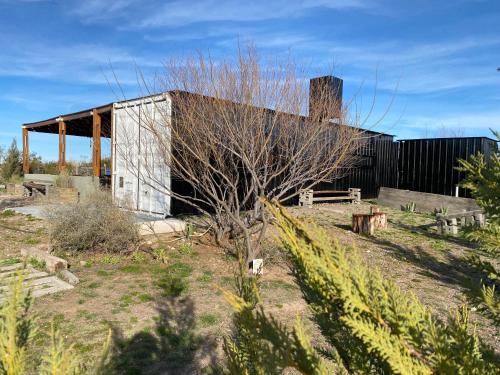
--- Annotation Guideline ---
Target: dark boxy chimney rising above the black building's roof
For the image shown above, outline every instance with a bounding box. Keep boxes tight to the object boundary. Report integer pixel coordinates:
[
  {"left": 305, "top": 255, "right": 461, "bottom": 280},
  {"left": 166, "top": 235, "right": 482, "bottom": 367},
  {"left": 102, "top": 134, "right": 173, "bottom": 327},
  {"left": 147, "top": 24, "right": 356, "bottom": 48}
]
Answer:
[{"left": 309, "top": 76, "right": 344, "bottom": 120}]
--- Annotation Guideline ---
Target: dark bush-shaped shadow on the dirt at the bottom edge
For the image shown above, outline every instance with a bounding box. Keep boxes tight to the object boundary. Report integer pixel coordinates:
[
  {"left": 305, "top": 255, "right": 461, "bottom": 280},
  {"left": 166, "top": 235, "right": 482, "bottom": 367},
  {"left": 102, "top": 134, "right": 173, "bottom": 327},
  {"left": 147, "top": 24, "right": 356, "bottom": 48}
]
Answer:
[{"left": 107, "top": 297, "right": 217, "bottom": 375}]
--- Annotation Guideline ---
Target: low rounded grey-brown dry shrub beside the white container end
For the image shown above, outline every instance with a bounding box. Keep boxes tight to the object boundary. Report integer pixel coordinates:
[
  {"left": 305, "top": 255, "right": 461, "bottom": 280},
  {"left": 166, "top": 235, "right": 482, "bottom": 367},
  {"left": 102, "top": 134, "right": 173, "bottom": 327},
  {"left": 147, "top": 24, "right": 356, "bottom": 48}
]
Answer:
[{"left": 47, "top": 191, "right": 139, "bottom": 253}]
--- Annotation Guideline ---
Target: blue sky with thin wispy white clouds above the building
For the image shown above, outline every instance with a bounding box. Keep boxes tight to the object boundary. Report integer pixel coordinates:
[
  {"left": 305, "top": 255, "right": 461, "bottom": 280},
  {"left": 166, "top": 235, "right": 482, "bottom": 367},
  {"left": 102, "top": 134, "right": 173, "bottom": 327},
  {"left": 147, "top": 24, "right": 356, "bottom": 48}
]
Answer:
[{"left": 0, "top": 0, "right": 500, "bottom": 160}]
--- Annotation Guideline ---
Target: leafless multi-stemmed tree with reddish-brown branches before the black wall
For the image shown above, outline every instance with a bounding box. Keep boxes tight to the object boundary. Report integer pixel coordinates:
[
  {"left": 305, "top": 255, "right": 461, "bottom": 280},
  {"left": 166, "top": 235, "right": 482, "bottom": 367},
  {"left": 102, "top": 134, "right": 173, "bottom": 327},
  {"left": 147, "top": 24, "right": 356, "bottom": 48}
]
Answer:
[{"left": 117, "top": 47, "right": 364, "bottom": 261}]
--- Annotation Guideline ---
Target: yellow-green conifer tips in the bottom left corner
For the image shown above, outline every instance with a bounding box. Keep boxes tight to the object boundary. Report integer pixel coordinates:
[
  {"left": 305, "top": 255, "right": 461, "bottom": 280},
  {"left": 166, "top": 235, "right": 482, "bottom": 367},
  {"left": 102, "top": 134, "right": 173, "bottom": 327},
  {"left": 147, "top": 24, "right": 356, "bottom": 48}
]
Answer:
[{"left": 0, "top": 275, "right": 111, "bottom": 375}]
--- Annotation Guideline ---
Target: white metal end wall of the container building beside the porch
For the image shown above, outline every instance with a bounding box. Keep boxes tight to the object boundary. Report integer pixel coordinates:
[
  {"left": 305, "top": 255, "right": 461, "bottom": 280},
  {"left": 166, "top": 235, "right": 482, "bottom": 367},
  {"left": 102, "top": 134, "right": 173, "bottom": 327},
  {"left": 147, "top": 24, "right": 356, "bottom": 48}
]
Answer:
[{"left": 112, "top": 95, "right": 171, "bottom": 217}]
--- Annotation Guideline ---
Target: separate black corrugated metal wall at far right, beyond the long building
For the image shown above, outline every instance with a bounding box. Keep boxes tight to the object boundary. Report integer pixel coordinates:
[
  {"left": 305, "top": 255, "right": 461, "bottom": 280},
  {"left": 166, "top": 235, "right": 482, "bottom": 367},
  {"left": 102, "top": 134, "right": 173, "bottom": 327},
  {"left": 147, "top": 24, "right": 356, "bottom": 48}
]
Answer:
[{"left": 396, "top": 137, "right": 497, "bottom": 198}]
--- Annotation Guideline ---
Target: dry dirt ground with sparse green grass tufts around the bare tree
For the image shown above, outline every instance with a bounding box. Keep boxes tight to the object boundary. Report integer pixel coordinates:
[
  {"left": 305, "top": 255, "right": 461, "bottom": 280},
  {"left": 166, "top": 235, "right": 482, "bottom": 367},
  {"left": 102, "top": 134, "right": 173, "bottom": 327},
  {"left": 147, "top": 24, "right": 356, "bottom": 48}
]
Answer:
[{"left": 0, "top": 192, "right": 499, "bottom": 374}]
